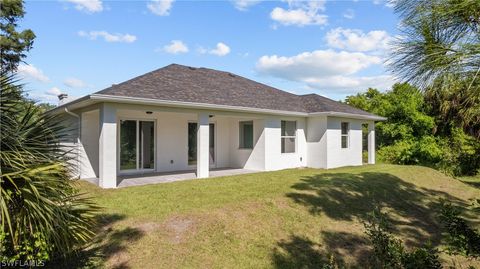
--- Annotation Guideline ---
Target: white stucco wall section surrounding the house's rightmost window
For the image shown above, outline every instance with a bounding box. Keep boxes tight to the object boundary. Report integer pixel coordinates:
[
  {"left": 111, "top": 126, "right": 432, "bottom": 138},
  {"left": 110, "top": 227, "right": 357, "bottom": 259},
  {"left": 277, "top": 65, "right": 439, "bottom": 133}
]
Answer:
[{"left": 326, "top": 117, "right": 362, "bottom": 168}]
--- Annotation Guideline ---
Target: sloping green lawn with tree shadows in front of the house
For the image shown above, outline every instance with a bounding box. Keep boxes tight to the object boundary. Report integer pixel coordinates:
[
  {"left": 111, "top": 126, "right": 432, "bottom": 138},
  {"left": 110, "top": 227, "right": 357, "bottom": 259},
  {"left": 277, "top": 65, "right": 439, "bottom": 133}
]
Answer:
[{"left": 60, "top": 165, "right": 480, "bottom": 268}]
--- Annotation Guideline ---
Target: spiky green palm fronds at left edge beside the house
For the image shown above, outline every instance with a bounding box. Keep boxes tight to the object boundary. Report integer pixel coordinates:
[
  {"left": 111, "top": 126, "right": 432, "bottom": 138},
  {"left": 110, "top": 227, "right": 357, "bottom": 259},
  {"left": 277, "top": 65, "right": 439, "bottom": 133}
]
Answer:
[{"left": 0, "top": 74, "right": 97, "bottom": 260}]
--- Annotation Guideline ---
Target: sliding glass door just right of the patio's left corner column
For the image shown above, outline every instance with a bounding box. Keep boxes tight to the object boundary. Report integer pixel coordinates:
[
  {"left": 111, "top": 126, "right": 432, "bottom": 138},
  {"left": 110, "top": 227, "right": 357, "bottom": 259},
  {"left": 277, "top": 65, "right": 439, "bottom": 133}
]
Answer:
[{"left": 120, "top": 120, "right": 155, "bottom": 171}]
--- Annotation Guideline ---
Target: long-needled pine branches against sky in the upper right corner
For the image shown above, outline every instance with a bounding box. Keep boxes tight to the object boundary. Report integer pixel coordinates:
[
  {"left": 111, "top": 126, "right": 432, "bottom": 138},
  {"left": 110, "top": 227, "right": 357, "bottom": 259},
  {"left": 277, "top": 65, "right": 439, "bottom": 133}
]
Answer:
[{"left": 390, "top": 0, "right": 480, "bottom": 88}]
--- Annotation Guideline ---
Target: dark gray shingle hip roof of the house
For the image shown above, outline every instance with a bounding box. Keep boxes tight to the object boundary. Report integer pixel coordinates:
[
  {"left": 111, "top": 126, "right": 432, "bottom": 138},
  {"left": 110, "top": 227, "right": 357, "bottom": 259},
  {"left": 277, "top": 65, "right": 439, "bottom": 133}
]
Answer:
[{"left": 96, "top": 64, "right": 374, "bottom": 116}]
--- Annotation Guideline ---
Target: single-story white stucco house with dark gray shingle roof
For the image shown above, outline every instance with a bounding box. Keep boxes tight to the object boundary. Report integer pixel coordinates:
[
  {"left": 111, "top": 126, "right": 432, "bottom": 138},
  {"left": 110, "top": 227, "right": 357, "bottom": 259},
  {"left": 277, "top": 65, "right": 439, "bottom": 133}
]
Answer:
[{"left": 53, "top": 64, "right": 384, "bottom": 188}]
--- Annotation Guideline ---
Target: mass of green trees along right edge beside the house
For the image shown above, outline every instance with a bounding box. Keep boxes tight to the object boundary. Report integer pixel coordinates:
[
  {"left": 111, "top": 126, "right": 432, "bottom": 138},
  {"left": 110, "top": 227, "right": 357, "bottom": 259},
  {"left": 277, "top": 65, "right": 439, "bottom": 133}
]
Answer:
[{"left": 345, "top": 0, "right": 480, "bottom": 175}]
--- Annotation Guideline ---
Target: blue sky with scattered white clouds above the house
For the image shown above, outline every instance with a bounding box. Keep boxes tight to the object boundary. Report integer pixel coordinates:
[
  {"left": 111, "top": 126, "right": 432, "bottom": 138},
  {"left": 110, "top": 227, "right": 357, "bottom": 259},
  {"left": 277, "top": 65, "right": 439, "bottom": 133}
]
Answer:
[{"left": 18, "top": 0, "right": 398, "bottom": 104}]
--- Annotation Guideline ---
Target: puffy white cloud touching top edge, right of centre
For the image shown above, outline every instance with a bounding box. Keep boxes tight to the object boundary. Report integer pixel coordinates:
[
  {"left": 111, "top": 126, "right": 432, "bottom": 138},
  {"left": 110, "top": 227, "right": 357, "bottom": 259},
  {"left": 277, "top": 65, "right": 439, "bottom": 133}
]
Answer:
[{"left": 270, "top": 0, "right": 328, "bottom": 26}]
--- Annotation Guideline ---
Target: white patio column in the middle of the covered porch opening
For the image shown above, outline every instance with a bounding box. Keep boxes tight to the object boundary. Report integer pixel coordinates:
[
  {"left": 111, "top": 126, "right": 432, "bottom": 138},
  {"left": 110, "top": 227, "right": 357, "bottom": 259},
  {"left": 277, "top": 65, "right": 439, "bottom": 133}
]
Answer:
[{"left": 197, "top": 113, "right": 210, "bottom": 178}]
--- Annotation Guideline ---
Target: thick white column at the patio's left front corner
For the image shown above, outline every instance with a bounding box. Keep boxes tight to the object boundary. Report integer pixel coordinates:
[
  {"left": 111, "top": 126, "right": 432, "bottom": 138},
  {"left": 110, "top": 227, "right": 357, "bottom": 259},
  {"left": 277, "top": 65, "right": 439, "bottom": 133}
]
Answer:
[{"left": 98, "top": 103, "right": 117, "bottom": 188}]
